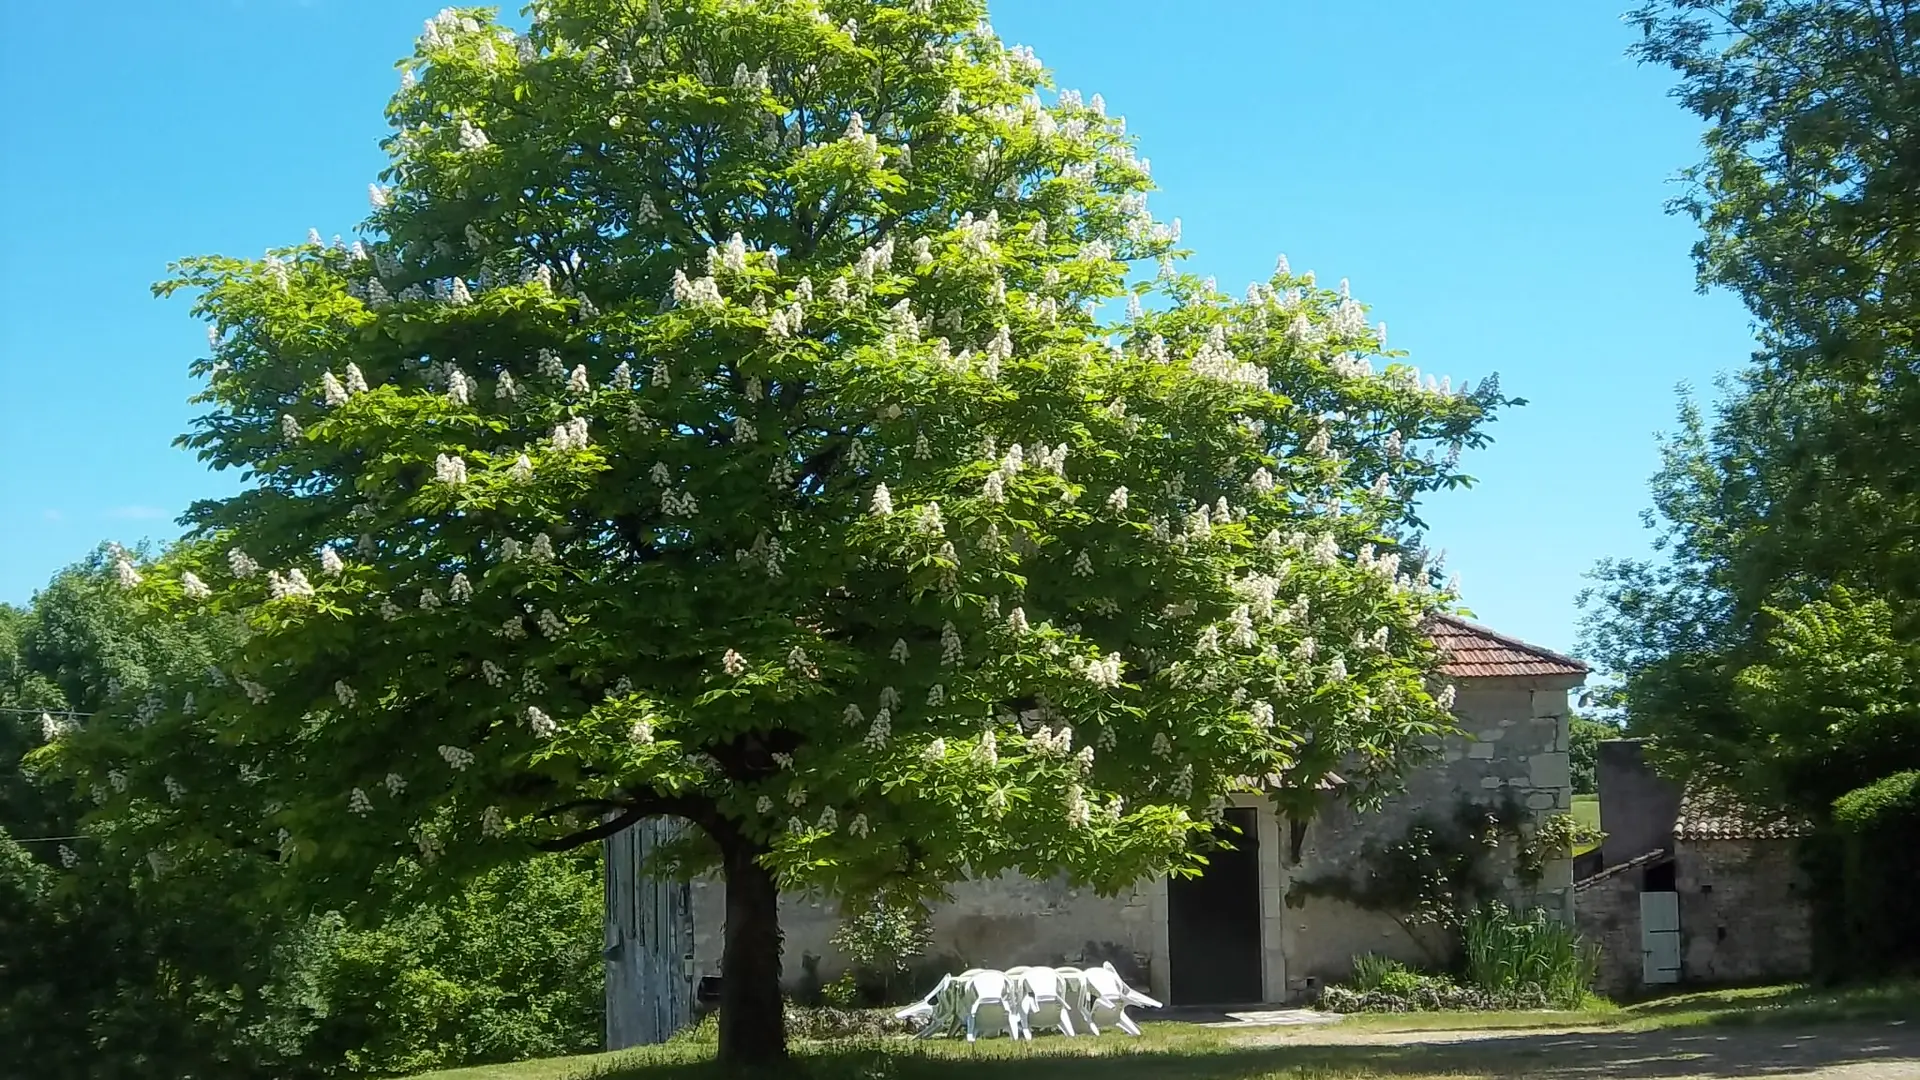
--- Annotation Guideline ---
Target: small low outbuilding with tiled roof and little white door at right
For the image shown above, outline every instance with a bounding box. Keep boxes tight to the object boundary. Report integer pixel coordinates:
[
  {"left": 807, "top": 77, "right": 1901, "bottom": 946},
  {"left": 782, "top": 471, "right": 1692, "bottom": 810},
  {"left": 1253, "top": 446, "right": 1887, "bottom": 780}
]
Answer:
[{"left": 1574, "top": 740, "right": 1812, "bottom": 997}]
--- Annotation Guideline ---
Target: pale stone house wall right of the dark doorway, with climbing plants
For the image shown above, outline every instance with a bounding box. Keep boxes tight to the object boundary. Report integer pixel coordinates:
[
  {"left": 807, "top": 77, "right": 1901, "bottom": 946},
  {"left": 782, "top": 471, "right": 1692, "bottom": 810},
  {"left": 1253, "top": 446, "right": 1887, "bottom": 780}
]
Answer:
[{"left": 1283, "top": 678, "right": 1578, "bottom": 997}]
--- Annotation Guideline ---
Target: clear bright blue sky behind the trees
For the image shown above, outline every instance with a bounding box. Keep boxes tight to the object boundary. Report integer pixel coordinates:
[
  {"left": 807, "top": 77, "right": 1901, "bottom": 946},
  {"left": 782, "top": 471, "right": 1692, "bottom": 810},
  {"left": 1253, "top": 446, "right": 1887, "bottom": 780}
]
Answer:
[{"left": 0, "top": 0, "right": 1751, "bottom": 648}]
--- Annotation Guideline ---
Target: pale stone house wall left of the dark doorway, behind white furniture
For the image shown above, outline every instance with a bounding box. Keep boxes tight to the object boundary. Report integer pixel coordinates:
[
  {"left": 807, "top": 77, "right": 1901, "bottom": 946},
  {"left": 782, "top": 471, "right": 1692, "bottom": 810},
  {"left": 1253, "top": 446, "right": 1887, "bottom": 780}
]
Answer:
[{"left": 693, "top": 874, "right": 1158, "bottom": 988}]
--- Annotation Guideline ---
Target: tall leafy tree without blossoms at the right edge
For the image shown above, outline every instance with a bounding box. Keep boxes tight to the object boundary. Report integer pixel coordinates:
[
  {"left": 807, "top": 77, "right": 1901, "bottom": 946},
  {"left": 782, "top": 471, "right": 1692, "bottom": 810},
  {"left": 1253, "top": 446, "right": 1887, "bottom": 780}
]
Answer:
[{"left": 1588, "top": 0, "right": 1920, "bottom": 819}]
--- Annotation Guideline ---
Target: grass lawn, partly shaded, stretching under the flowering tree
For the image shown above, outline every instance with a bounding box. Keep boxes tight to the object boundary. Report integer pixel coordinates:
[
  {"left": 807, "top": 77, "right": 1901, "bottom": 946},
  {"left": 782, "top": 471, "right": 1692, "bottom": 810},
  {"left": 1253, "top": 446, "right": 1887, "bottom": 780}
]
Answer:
[{"left": 405, "top": 982, "right": 1920, "bottom": 1080}]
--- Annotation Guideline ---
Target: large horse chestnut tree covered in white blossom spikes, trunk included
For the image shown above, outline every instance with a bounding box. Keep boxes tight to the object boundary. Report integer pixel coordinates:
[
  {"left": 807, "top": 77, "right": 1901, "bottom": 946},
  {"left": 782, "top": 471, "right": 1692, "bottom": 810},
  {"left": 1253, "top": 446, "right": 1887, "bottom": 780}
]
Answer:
[{"left": 45, "top": 0, "right": 1503, "bottom": 1061}]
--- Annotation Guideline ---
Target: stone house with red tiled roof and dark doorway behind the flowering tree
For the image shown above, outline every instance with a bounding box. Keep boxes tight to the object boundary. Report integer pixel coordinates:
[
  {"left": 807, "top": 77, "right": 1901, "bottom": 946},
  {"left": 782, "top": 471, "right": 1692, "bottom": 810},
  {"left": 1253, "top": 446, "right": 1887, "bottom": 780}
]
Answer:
[{"left": 607, "top": 617, "right": 1588, "bottom": 1047}]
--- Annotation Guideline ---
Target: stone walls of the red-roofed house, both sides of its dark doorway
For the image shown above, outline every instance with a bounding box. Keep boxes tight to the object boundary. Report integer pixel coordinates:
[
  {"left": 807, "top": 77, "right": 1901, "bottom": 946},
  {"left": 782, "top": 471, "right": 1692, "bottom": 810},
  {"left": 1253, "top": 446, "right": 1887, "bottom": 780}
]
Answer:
[{"left": 675, "top": 678, "right": 1576, "bottom": 1001}]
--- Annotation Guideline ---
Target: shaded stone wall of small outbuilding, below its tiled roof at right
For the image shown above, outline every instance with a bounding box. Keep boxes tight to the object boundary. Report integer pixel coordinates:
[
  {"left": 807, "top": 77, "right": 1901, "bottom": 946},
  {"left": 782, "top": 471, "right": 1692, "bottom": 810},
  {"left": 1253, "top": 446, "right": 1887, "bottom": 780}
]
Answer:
[{"left": 1674, "top": 840, "right": 1812, "bottom": 982}]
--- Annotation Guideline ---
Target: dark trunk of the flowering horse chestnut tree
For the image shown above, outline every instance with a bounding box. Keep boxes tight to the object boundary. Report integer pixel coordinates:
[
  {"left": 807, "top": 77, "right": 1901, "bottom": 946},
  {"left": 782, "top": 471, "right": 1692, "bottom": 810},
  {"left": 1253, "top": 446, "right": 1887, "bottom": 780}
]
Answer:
[{"left": 720, "top": 840, "right": 787, "bottom": 1065}]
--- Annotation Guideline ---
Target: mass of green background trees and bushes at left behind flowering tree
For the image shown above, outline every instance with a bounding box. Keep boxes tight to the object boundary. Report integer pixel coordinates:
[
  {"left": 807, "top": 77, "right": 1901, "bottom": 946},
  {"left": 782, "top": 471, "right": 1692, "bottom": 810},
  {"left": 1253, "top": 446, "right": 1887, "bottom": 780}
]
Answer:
[{"left": 0, "top": 548, "right": 603, "bottom": 1080}]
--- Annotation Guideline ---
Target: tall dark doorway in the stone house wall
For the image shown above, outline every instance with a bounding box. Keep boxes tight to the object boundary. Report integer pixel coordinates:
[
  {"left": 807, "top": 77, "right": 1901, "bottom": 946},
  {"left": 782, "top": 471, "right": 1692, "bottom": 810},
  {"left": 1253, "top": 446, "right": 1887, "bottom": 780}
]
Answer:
[{"left": 1167, "top": 809, "right": 1263, "bottom": 1005}]
